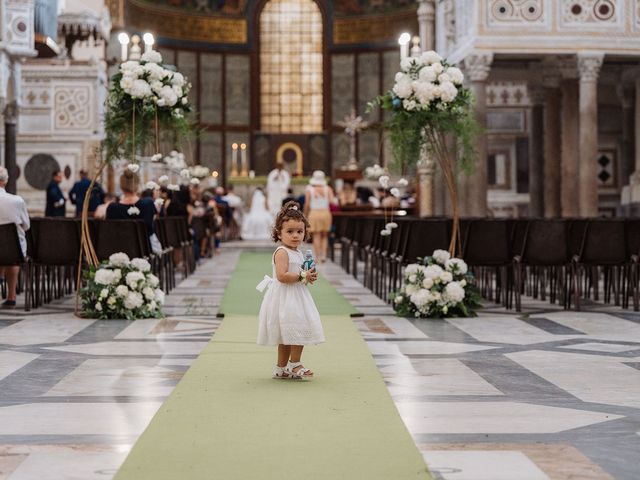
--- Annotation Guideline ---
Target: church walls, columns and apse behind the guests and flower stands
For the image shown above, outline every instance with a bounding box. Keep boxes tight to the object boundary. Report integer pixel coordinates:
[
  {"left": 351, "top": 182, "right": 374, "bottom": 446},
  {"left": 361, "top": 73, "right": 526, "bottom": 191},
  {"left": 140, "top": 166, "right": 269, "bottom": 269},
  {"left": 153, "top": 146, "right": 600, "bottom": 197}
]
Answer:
[{"left": 2, "top": 0, "right": 640, "bottom": 217}]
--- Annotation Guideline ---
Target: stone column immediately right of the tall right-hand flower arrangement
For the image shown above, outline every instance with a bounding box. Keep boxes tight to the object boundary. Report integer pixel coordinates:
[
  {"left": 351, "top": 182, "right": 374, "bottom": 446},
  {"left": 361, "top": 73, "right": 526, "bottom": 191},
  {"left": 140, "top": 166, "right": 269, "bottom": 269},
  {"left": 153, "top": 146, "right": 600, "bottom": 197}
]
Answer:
[{"left": 460, "top": 53, "right": 493, "bottom": 217}]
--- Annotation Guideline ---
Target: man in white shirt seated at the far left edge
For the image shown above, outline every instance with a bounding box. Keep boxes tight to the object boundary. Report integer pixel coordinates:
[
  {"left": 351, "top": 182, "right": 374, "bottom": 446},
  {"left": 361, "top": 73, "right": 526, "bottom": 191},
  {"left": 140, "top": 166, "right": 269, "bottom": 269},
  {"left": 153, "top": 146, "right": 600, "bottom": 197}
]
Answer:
[{"left": 0, "top": 167, "right": 31, "bottom": 308}]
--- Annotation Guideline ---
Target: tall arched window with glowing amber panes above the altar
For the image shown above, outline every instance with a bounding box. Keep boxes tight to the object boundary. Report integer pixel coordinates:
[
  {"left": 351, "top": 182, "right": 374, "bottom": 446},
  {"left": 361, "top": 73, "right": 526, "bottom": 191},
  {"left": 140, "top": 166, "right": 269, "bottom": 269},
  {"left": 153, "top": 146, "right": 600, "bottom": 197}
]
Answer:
[{"left": 260, "top": 0, "right": 323, "bottom": 133}]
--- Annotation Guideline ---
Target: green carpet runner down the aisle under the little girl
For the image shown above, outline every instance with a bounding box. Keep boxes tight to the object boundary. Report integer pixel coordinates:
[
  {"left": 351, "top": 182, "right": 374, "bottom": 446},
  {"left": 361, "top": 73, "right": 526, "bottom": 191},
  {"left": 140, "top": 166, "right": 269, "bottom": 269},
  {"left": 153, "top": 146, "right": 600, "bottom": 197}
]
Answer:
[{"left": 115, "top": 253, "right": 430, "bottom": 480}]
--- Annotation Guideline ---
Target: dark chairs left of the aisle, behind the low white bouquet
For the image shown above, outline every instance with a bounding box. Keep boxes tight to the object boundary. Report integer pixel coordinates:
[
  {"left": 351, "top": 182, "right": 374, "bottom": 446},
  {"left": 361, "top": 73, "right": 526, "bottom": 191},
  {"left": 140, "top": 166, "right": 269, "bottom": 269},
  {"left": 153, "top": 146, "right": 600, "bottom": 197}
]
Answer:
[{"left": 0, "top": 217, "right": 195, "bottom": 310}]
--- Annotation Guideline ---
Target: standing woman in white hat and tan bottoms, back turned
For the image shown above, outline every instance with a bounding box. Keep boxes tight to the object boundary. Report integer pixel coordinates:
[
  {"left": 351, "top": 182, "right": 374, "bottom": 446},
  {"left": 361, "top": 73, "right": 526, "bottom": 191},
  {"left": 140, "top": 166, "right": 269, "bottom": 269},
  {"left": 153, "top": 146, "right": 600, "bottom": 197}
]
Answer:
[{"left": 304, "top": 170, "right": 334, "bottom": 263}]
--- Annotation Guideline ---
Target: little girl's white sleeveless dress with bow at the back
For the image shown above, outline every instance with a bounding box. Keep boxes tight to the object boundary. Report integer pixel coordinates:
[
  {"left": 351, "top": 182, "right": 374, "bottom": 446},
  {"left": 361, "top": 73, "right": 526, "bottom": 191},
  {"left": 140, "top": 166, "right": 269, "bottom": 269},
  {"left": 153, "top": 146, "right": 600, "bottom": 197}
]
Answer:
[{"left": 257, "top": 246, "right": 324, "bottom": 345}]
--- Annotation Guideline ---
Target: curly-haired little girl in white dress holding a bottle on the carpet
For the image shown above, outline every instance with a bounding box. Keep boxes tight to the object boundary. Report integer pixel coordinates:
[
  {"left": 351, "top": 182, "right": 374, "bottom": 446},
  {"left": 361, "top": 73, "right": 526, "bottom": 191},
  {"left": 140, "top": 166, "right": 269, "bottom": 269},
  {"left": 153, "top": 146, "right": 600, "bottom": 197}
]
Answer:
[{"left": 256, "top": 202, "right": 324, "bottom": 378}]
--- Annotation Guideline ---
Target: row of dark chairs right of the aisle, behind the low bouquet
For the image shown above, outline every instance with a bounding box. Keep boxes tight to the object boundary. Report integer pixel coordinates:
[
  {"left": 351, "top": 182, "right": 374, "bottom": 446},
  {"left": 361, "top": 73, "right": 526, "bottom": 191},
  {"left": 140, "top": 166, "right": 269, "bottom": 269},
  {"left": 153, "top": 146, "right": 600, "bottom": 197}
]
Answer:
[{"left": 331, "top": 216, "right": 640, "bottom": 311}]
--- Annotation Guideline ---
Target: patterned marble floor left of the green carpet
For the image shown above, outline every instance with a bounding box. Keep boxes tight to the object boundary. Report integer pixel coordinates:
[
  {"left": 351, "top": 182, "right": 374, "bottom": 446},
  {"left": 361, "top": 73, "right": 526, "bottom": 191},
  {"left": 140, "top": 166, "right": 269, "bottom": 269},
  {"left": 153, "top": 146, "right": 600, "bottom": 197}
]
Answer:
[{"left": 0, "top": 249, "right": 239, "bottom": 480}]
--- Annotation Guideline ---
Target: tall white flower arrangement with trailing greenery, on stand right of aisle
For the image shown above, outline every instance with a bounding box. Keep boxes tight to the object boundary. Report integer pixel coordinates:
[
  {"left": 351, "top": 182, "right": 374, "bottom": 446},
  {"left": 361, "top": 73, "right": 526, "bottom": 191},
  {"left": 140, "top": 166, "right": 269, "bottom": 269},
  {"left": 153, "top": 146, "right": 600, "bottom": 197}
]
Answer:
[{"left": 369, "top": 51, "right": 479, "bottom": 255}]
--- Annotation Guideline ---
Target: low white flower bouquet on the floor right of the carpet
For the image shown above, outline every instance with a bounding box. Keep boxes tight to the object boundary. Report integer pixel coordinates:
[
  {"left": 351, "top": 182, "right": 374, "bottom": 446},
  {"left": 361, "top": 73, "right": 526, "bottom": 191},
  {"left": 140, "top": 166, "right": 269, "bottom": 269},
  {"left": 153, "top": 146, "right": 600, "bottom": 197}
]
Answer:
[{"left": 391, "top": 250, "right": 480, "bottom": 318}]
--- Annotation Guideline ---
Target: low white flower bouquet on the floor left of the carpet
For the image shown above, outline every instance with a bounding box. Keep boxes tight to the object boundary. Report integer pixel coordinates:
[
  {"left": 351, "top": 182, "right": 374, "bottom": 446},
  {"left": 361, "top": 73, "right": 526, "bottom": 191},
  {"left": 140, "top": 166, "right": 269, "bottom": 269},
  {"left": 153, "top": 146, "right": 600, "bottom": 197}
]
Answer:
[{"left": 80, "top": 253, "right": 164, "bottom": 320}]
